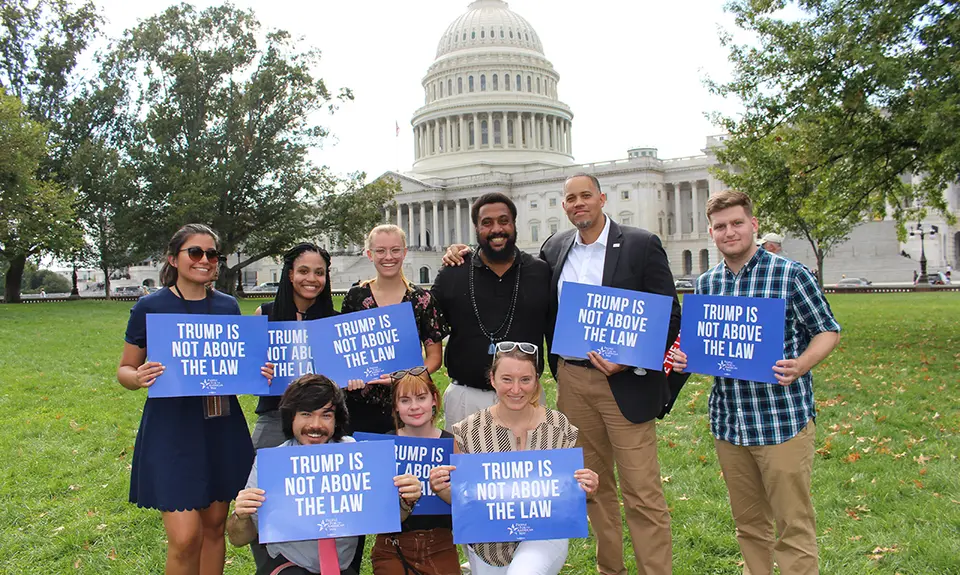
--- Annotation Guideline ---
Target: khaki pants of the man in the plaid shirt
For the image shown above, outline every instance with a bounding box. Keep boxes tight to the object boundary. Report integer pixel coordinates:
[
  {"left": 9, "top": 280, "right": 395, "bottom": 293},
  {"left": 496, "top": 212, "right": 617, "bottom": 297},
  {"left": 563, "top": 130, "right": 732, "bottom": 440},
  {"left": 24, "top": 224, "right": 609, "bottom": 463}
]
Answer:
[{"left": 714, "top": 420, "right": 820, "bottom": 575}]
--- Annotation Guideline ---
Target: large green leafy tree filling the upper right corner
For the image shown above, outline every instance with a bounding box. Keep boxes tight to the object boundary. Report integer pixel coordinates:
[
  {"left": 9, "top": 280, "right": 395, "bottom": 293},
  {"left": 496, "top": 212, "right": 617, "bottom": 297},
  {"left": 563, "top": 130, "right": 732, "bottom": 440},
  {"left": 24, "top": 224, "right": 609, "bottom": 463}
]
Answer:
[{"left": 710, "top": 0, "right": 960, "bottom": 278}]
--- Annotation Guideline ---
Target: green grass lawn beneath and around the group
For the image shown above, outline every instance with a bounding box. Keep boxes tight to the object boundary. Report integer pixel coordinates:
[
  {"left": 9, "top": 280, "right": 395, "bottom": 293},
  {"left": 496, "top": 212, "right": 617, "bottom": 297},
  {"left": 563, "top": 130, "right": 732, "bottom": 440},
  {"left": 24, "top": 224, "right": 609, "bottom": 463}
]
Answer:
[{"left": 0, "top": 293, "right": 960, "bottom": 575}]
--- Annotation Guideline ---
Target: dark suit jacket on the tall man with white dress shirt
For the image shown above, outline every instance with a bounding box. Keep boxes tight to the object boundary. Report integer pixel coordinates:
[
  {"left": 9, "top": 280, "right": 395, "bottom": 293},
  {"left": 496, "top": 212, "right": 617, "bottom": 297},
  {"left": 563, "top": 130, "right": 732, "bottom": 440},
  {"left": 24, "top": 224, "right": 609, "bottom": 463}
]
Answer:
[{"left": 540, "top": 220, "right": 686, "bottom": 423}]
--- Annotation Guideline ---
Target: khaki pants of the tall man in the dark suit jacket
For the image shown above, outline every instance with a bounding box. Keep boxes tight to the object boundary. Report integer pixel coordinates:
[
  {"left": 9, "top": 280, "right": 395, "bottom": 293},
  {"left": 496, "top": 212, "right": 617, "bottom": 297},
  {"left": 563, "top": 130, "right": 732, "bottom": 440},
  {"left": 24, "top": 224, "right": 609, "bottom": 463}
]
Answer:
[{"left": 557, "top": 359, "right": 673, "bottom": 575}]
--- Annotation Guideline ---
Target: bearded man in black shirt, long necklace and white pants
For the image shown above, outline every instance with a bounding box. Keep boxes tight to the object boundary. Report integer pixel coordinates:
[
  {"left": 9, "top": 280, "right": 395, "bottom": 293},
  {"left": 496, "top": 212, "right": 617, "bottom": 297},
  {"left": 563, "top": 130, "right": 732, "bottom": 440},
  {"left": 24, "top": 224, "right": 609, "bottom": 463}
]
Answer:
[{"left": 432, "top": 193, "right": 550, "bottom": 430}]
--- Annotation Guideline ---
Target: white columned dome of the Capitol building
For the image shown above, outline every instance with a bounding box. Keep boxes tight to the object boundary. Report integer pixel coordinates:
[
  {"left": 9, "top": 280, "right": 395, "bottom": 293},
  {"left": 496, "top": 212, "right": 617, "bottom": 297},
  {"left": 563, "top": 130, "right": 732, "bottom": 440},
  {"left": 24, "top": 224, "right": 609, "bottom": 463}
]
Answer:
[{"left": 412, "top": 0, "right": 573, "bottom": 177}]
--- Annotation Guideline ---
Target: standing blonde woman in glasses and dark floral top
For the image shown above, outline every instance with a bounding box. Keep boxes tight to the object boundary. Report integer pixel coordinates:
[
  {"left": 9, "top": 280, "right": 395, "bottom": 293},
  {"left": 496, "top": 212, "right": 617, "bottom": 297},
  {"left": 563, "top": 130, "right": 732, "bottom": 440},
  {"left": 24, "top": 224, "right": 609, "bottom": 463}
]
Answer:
[{"left": 341, "top": 224, "right": 450, "bottom": 433}]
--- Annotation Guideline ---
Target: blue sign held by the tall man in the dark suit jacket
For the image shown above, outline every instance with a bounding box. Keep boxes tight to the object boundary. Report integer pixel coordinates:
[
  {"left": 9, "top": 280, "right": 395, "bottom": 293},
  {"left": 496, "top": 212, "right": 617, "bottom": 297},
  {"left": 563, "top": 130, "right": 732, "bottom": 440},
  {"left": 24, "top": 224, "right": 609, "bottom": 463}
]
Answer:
[{"left": 550, "top": 282, "right": 673, "bottom": 371}]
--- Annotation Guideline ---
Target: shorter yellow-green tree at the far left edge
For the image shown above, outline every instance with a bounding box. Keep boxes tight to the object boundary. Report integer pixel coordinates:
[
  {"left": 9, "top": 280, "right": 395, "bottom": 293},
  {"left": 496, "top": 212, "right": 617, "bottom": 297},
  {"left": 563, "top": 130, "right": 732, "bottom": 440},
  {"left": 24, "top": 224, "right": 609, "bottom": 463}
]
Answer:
[{"left": 0, "top": 89, "right": 80, "bottom": 303}]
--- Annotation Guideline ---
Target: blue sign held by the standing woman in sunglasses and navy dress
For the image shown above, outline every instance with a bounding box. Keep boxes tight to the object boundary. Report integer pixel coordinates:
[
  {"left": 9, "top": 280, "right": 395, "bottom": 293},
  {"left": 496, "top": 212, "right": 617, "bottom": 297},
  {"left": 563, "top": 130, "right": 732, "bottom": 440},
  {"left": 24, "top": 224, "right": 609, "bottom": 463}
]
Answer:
[{"left": 147, "top": 313, "right": 268, "bottom": 397}]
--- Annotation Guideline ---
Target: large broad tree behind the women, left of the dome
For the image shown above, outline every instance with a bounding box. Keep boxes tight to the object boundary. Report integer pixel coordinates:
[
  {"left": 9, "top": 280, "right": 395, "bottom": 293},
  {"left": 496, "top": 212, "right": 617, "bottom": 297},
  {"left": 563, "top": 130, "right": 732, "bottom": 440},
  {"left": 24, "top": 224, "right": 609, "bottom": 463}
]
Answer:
[{"left": 102, "top": 4, "right": 353, "bottom": 293}]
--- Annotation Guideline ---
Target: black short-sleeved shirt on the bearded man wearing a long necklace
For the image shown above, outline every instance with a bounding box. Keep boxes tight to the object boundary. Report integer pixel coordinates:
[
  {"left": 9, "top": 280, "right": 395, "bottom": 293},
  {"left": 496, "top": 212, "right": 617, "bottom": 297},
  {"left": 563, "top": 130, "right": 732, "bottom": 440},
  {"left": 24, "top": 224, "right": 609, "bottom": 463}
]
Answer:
[{"left": 432, "top": 250, "right": 550, "bottom": 390}]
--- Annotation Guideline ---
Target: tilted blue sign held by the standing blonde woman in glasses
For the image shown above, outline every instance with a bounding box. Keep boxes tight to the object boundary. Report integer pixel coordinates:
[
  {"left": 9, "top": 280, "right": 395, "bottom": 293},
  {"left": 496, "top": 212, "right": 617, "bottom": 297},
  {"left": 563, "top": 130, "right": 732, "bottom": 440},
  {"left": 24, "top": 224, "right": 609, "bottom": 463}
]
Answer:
[{"left": 305, "top": 302, "right": 423, "bottom": 387}]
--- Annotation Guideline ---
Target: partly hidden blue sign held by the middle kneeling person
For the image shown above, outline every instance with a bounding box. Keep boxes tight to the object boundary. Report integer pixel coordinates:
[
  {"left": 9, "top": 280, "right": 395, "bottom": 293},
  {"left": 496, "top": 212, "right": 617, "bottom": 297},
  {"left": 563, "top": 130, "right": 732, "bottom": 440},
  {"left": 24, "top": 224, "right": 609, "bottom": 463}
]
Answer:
[{"left": 353, "top": 432, "right": 453, "bottom": 515}]
